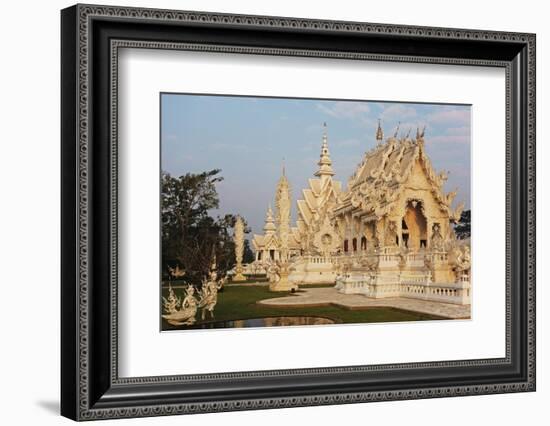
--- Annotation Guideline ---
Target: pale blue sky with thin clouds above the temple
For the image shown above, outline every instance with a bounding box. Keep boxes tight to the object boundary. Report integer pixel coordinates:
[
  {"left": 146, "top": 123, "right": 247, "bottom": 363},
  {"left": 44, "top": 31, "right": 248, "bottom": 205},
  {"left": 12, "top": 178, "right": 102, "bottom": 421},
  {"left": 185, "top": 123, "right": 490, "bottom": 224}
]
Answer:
[{"left": 161, "top": 94, "right": 471, "bottom": 233}]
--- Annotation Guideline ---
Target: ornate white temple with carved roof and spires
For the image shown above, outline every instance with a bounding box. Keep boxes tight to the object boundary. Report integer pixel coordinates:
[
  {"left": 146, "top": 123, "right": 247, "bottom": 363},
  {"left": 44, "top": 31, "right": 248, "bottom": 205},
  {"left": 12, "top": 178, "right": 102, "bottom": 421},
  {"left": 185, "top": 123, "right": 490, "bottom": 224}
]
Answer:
[{"left": 251, "top": 123, "right": 470, "bottom": 304}]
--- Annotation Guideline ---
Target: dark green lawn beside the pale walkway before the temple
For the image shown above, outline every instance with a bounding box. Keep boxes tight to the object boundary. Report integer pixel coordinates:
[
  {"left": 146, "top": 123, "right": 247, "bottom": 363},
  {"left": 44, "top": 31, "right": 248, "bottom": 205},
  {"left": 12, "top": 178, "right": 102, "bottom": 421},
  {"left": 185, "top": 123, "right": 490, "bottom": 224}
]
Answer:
[{"left": 163, "top": 285, "right": 441, "bottom": 330}]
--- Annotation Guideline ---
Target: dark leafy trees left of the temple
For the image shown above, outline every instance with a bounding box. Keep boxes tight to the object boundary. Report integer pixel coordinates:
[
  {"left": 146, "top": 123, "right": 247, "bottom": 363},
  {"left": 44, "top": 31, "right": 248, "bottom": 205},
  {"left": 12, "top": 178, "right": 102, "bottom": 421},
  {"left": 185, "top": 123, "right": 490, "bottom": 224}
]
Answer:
[{"left": 161, "top": 169, "right": 253, "bottom": 286}]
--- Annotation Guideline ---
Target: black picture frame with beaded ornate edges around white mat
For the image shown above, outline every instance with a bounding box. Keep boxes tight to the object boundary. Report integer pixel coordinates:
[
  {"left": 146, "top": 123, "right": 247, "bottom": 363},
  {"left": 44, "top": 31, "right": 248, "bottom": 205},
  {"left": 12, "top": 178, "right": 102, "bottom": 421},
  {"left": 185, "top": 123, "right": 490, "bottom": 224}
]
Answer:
[{"left": 61, "top": 5, "right": 536, "bottom": 420}]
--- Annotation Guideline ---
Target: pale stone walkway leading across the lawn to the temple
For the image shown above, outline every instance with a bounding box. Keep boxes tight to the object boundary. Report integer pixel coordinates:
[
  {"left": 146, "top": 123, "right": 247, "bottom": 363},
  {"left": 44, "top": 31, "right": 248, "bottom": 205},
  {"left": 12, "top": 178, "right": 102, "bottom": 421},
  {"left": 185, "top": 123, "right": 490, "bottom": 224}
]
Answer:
[{"left": 257, "top": 287, "right": 470, "bottom": 319}]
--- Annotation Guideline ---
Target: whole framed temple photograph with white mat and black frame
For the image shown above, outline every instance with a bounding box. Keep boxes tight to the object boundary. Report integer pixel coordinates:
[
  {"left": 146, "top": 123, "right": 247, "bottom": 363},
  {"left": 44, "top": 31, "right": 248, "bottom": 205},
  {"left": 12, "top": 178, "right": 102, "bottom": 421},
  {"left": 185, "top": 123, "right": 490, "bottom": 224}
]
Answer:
[{"left": 61, "top": 5, "right": 535, "bottom": 420}]
